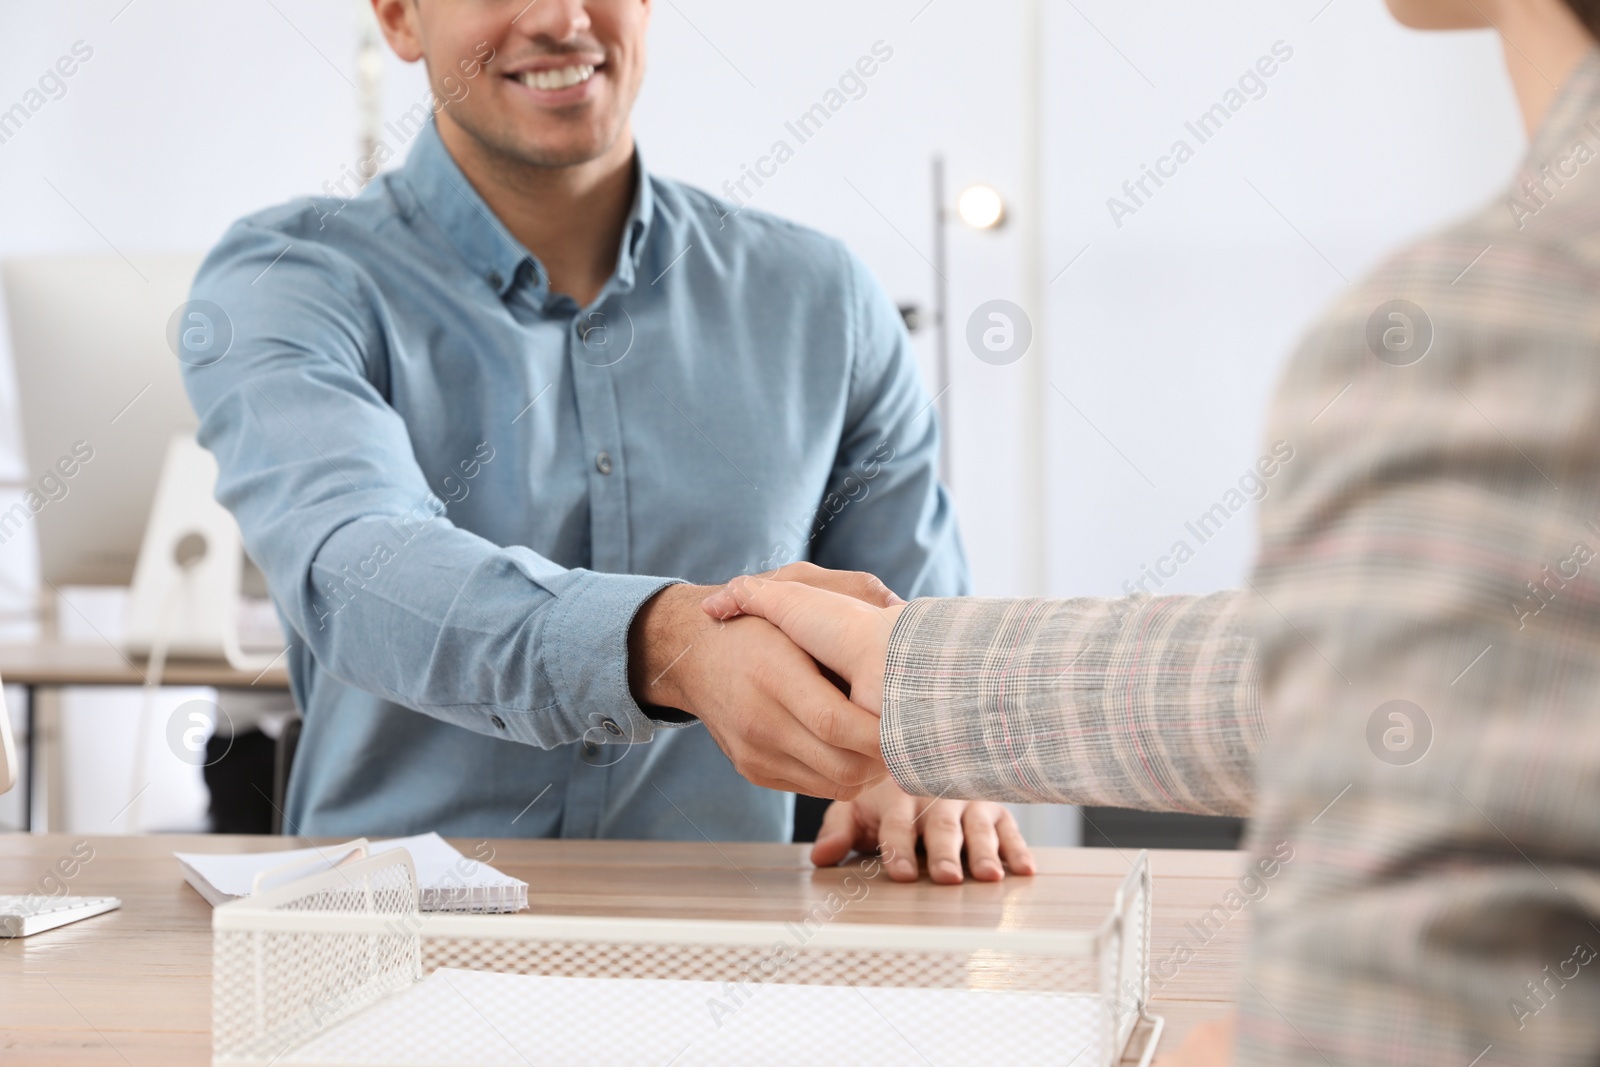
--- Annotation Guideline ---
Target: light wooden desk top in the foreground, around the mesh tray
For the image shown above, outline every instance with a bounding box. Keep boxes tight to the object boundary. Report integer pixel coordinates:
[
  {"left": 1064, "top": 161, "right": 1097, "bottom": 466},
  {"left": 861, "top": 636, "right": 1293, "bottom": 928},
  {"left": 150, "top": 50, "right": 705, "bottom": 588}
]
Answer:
[{"left": 0, "top": 833, "right": 1248, "bottom": 1067}]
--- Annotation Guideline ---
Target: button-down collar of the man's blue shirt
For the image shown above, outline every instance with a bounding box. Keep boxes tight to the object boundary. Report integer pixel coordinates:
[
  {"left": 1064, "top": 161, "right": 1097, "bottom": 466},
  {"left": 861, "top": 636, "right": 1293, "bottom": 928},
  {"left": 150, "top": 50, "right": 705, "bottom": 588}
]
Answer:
[{"left": 402, "top": 122, "right": 656, "bottom": 298}]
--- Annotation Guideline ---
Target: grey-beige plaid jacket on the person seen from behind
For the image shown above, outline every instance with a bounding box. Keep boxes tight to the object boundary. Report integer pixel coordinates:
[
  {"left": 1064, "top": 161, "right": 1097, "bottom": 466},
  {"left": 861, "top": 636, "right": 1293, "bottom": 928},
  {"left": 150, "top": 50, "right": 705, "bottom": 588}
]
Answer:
[{"left": 883, "top": 53, "right": 1600, "bottom": 1067}]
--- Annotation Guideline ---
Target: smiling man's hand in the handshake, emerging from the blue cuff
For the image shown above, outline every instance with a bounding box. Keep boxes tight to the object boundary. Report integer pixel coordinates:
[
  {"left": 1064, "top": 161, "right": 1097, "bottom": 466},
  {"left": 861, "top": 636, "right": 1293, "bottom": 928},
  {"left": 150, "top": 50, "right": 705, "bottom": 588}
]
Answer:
[{"left": 629, "top": 585, "right": 888, "bottom": 800}]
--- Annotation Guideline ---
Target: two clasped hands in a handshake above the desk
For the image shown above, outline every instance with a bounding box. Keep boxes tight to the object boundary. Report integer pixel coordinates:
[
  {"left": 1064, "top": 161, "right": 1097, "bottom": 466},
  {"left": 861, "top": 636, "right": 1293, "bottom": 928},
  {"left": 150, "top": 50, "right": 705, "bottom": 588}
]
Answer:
[{"left": 629, "top": 563, "right": 904, "bottom": 800}]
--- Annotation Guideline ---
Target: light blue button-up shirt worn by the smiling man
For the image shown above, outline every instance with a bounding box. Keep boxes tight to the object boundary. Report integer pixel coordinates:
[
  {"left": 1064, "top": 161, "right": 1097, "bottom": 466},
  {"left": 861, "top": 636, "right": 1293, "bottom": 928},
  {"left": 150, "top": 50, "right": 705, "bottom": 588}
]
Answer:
[{"left": 182, "top": 126, "right": 970, "bottom": 840}]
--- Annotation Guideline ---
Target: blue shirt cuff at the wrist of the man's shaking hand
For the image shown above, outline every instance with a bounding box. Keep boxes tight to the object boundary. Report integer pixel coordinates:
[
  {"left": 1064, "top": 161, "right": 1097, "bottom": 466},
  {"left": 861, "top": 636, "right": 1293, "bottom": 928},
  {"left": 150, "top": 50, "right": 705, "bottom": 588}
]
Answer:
[{"left": 542, "top": 571, "right": 694, "bottom": 744}]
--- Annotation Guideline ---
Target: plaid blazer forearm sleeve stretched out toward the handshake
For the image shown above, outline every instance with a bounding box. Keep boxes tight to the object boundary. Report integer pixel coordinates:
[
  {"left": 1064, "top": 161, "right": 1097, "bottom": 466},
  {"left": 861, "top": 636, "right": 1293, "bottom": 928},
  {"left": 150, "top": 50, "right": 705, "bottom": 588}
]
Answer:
[{"left": 882, "top": 592, "right": 1266, "bottom": 814}]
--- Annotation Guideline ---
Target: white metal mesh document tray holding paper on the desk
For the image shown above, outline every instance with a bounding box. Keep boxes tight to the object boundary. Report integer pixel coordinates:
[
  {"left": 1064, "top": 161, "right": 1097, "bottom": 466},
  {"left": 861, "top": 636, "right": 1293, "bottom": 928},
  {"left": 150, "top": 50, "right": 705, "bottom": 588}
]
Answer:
[{"left": 211, "top": 851, "right": 1162, "bottom": 1067}]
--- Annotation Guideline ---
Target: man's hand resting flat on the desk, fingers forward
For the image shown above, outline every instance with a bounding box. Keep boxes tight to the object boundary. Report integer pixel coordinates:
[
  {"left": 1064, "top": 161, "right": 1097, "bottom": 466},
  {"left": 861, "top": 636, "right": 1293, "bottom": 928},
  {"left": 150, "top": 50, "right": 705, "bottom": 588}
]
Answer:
[{"left": 811, "top": 779, "right": 1034, "bottom": 885}]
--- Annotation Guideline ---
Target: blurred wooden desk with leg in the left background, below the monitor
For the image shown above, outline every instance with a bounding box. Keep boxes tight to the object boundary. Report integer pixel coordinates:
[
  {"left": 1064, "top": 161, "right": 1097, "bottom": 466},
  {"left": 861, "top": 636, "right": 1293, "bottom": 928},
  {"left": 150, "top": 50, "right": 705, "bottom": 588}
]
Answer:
[{"left": 0, "top": 641, "right": 290, "bottom": 830}]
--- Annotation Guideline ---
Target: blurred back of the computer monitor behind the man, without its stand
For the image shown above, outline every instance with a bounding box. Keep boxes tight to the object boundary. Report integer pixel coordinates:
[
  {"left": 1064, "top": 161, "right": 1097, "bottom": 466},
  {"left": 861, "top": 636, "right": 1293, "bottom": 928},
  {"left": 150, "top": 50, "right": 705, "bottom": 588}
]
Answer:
[{"left": 0, "top": 253, "right": 202, "bottom": 585}]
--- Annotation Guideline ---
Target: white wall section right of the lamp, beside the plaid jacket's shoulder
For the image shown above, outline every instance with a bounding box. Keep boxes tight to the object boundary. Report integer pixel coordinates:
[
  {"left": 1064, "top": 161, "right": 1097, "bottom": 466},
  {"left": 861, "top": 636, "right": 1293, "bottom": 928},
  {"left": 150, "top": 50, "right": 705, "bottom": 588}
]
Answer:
[{"left": 1046, "top": 0, "right": 1523, "bottom": 595}]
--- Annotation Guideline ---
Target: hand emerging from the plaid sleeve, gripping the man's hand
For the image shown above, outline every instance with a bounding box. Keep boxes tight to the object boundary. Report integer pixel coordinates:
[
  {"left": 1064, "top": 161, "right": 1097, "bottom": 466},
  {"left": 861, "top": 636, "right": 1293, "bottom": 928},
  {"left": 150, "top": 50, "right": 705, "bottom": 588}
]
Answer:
[{"left": 702, "top": 565, "right": 906, "bottom": 713}]
